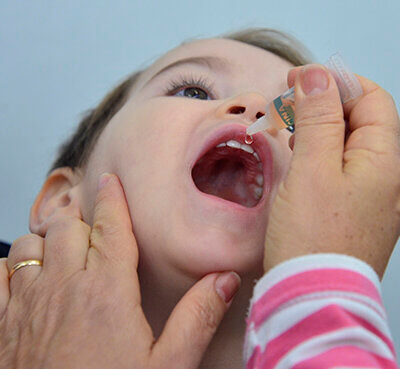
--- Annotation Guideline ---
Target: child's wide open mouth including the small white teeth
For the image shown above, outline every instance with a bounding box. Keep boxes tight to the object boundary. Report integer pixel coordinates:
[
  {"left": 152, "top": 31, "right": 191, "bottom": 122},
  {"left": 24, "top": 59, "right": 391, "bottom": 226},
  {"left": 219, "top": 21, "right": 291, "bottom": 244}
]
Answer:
[{"left": 192, "top": 139, "right": 264, "bottom": 208}]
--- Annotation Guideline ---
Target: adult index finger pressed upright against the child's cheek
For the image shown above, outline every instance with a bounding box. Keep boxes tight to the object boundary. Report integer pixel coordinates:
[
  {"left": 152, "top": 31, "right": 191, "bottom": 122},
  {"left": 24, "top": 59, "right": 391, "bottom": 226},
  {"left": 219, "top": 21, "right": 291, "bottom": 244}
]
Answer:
[{"left": 88, "top": 173, "right": 138, "bottom": 273}]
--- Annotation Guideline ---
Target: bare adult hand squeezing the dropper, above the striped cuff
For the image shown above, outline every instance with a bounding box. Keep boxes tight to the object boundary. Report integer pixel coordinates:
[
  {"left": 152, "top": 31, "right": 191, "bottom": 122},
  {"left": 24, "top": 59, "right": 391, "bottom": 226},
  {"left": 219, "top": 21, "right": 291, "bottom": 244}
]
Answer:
[{"left": 264, "top": 65, "right": 400, "bottom": 278}]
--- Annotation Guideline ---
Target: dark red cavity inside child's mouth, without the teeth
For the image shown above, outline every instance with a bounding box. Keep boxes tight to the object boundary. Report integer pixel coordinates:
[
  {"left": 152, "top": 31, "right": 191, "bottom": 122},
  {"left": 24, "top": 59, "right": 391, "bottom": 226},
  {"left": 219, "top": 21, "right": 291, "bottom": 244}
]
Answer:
[{"left": 192, "top": 155, "right": 258, "bottom": 207}]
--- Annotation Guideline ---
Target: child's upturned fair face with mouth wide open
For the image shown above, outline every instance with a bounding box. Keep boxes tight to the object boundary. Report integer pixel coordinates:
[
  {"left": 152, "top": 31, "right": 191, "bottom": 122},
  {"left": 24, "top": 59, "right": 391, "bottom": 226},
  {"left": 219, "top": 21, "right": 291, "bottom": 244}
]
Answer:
[{"left": 82, "top": 39, "right": 292, "bottom": 278}]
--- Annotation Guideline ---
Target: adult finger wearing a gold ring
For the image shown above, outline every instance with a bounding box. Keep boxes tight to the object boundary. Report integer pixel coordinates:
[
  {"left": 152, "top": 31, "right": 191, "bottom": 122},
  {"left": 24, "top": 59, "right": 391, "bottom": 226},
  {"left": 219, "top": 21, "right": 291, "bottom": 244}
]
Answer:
[{"left": 7, "top": 234, "right": 44, "bottom": 295}]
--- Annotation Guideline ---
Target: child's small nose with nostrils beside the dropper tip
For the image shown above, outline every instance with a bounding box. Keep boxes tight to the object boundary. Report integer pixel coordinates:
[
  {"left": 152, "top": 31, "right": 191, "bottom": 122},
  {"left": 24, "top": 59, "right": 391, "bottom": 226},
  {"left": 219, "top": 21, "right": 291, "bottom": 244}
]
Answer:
[{"left": 216, "top": 92, "right": 267, "bottom": 123}]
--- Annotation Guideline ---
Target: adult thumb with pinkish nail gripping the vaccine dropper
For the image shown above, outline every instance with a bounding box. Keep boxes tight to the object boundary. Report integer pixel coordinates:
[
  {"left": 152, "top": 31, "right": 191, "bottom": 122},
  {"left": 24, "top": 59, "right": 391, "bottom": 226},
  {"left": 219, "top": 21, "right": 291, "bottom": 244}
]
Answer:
[{"left": 292, "top": 64, "right": 345, "bottom": 174}]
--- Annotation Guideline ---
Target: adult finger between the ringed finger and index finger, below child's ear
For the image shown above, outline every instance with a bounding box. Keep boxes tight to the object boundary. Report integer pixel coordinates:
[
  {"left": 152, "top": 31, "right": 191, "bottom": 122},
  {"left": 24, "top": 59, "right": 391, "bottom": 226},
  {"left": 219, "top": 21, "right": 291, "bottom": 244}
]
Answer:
[{"left": 43, "top": 217, "right": 90, "bottom": 278}]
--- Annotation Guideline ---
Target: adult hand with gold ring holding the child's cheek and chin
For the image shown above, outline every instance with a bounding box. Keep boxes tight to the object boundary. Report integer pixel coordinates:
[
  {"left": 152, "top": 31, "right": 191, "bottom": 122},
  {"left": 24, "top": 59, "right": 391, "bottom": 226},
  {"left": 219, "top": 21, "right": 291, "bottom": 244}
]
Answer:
[{"left": 0, "top": 174, "right": 240, "bottom": 369}]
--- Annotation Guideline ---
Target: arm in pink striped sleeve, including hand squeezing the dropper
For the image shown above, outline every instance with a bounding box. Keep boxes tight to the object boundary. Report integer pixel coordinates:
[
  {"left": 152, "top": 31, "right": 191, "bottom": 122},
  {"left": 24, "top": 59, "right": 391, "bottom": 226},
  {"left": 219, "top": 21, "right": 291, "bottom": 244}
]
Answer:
[{"left": 250, "top": 65, "right": 400, "bottom": 369}]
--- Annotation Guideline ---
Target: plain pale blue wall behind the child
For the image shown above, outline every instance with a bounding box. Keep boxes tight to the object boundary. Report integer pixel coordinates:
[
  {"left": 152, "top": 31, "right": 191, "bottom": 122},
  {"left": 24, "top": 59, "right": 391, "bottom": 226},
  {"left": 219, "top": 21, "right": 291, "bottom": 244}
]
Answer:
[{"left": 0, "top": 0, "right": 400, "bottom": 354}]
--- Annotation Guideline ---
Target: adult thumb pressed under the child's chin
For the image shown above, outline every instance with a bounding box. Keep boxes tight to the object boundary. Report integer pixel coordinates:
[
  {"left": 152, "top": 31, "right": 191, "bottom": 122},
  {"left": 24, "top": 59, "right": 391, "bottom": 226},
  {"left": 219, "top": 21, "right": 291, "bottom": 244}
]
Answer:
[{"left": 152, "top": 272, "right": 240, "bottom": 369}]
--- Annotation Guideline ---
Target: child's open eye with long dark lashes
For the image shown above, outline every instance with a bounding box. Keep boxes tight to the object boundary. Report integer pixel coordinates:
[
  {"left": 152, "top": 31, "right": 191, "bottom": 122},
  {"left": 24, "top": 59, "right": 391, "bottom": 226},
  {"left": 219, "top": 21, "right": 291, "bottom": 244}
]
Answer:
[{"left": 165, "top": 76, "right": 214, "bottom": 100}]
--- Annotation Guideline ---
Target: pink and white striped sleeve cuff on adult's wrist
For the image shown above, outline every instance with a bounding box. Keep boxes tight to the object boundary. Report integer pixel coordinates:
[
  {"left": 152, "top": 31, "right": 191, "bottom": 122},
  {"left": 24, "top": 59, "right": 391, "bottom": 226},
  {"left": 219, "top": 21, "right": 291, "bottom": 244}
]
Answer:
[{"left": 244, "top": 254, "right": 398, "bottom": 369}]
